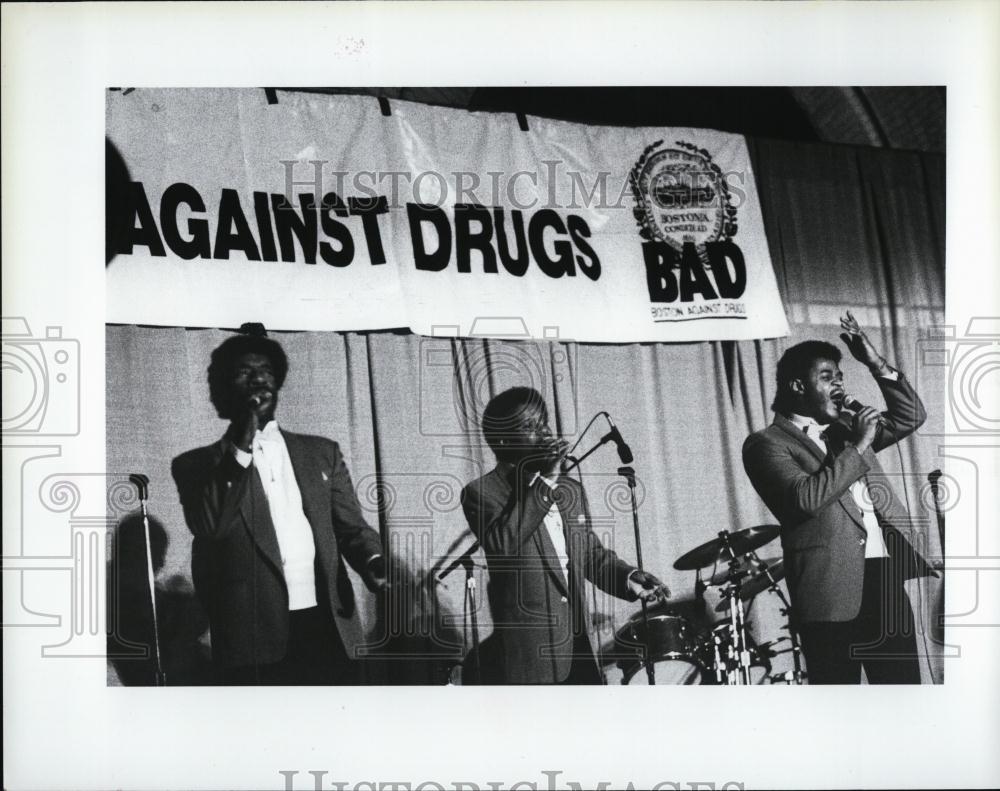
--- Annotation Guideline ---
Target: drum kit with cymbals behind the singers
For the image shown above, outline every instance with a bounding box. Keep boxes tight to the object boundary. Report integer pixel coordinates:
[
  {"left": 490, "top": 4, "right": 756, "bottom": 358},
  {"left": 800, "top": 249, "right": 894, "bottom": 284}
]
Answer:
[{"left": 602, "top": 525, "right": 806, "bottom": 686}]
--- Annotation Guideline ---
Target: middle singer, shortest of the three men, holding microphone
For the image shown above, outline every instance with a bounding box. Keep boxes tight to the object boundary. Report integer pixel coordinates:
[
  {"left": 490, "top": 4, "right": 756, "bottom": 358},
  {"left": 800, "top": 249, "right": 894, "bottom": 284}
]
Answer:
[{"left": 462, "top": 387, "right": 666, "bottom": 684}]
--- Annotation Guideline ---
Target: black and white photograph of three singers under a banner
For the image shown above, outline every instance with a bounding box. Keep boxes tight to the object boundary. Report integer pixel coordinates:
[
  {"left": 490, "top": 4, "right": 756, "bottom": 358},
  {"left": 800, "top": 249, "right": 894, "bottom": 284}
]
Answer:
[{"left": 106, "top": 86, "right": 946, "bottom": 685}]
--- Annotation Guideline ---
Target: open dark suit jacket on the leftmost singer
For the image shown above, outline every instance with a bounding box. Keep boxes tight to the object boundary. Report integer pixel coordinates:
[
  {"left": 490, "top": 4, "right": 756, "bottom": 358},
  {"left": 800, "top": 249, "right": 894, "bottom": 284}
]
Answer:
[{"left": 171, "top": 431, "right": 382, "bottom": 667}]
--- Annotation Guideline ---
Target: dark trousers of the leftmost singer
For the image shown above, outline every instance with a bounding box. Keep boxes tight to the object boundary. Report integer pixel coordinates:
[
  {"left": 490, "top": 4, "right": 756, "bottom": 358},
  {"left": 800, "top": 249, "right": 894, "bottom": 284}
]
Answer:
[{"left": 223, "top": 607, "right": 359, "bottom": 686}]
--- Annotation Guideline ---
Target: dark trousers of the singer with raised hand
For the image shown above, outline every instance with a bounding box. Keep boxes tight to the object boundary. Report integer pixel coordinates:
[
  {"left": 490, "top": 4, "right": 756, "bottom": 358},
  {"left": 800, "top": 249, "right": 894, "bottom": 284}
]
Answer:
[{"left": 799, "top": 558, "right": 920, "bottom": 684}]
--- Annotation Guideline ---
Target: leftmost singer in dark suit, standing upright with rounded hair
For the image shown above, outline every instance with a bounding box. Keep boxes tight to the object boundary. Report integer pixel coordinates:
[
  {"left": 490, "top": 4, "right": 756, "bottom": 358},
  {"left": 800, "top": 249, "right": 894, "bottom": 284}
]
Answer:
[{"left": 172, "top": 325, "right": 386, "bottom": 684}]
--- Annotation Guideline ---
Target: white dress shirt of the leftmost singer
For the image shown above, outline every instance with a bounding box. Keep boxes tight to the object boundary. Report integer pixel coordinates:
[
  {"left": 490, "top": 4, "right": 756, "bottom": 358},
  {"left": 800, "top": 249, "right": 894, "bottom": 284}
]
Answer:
[{"left": 229, "top": 420, "right": 317, "bottom": 610}]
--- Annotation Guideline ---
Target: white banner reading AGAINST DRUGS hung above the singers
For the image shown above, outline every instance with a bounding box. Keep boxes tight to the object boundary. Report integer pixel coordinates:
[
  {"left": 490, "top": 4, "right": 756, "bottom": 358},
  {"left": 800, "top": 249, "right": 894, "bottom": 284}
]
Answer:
[{"left": 107, "top": 89, "right": 788, "bottom": 342}]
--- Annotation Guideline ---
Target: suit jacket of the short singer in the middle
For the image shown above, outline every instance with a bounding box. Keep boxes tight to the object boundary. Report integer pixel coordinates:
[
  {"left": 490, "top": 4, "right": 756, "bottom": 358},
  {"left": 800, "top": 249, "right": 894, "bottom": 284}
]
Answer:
[{"left": 462, "top": 466, "right": 636, "bottom": 684}]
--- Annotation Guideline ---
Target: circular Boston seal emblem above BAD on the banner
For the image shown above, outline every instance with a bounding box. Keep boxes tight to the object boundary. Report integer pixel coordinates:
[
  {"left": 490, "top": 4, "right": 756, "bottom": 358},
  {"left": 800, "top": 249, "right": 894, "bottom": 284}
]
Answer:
[{"left": 631, "top": 140, "right": 737, "bottom": 254}]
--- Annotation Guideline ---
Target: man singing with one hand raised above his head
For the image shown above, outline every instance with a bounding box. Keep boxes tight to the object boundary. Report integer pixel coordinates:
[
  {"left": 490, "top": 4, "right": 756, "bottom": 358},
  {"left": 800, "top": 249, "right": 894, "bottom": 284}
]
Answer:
[{"left": 743, "top": 311, "right": 934, "bottom": 684}]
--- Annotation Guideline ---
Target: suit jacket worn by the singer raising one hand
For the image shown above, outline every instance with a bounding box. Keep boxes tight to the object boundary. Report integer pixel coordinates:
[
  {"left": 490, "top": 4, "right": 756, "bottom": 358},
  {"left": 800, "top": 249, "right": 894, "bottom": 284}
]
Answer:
[{"left": 743, "top": 374, "right": 934, "bottom": 623}]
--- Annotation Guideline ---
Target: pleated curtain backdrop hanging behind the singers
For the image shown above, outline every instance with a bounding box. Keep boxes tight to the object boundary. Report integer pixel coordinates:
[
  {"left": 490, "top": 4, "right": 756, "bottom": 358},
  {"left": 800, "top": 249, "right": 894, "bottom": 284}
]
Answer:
[{"left": 107, "top": 135, "right": 945, "bottom": 683}]
